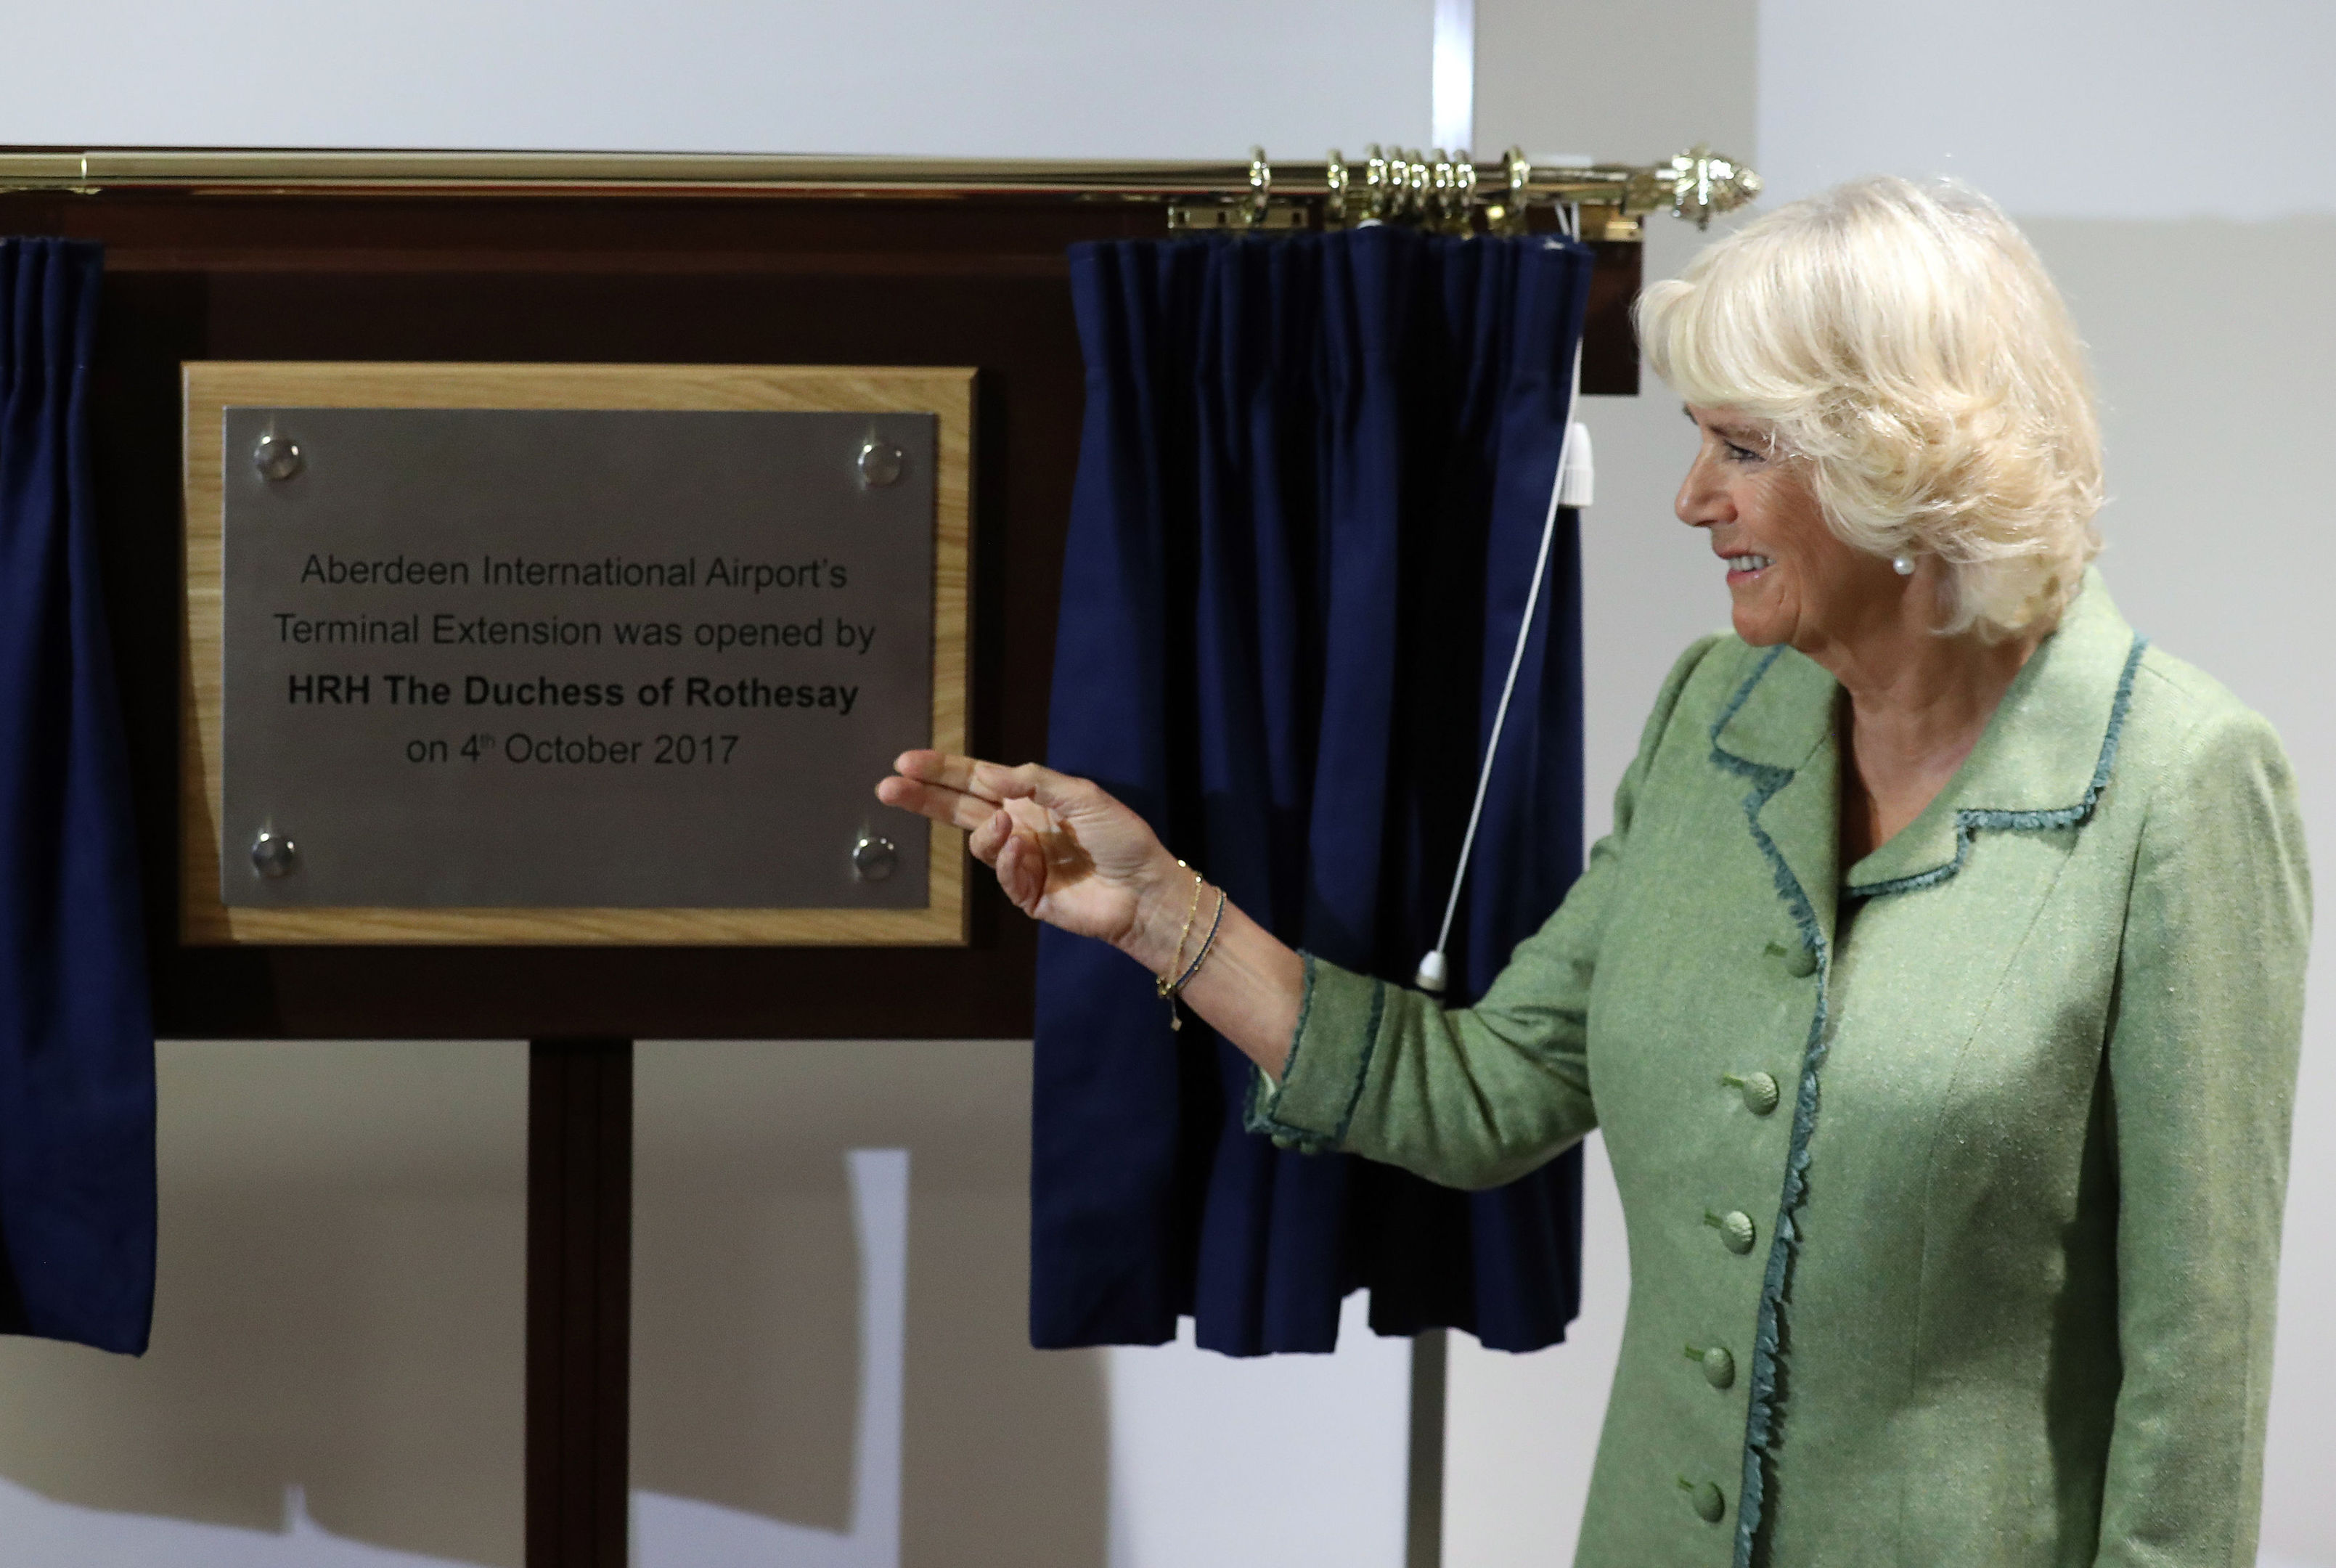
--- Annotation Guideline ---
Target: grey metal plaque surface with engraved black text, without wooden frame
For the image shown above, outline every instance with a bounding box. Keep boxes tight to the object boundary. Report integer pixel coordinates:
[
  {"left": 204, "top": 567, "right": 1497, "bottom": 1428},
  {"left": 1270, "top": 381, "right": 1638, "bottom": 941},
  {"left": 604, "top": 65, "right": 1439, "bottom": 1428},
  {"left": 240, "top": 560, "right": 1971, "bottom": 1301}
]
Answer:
[{"left": 219, "top": 407, "right": 936, "bottom": 909}]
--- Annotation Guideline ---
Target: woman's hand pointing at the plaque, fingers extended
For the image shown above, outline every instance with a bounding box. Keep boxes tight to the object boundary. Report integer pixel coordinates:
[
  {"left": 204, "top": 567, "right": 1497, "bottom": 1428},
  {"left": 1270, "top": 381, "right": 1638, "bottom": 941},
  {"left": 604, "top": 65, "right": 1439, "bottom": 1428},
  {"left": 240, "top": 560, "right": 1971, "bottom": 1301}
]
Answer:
[{"left": 876, "top": 750, "right": 1193, "bottom": 970}]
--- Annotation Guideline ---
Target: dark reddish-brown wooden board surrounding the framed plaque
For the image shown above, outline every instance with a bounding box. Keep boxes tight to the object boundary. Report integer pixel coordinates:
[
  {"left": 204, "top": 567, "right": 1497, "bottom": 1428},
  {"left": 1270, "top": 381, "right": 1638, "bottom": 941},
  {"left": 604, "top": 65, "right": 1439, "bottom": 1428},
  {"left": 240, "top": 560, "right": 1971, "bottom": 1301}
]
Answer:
[{"left": 0, "top": 192, "right": 1640, "bottom": 1040}]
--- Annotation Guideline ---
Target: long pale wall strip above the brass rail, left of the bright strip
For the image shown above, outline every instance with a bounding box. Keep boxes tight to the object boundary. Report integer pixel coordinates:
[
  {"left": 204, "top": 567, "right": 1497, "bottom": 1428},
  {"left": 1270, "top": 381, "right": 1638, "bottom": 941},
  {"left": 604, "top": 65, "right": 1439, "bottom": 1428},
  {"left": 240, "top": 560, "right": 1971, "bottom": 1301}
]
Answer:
[{"left": 0, "top": 0, "right": 1432, "bottom": 161}]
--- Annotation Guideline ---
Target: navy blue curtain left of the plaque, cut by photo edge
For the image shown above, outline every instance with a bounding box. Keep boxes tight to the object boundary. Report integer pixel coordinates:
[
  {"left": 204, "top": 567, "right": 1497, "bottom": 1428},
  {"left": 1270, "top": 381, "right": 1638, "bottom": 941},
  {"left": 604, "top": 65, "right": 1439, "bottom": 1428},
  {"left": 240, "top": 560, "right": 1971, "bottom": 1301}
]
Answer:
[{"left": 0, "top": 238, "right": 154, "bottom": 1353}]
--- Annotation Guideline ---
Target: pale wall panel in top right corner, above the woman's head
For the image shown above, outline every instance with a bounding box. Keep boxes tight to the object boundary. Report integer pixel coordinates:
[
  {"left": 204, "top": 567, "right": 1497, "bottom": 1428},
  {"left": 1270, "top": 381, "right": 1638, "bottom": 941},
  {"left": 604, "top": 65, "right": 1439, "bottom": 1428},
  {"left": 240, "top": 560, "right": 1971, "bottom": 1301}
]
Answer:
[{"left": 1759, "top": 0, "right": 2336, "bottom": 222}]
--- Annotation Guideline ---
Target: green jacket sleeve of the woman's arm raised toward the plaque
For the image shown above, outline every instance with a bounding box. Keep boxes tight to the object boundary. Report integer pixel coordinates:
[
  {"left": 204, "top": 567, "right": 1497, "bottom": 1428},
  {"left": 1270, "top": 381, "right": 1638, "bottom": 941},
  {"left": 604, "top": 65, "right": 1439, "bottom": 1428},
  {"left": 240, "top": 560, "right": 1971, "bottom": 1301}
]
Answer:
[{"left": 1247, "top": 638, "right": 1719, "bottom": 1187}]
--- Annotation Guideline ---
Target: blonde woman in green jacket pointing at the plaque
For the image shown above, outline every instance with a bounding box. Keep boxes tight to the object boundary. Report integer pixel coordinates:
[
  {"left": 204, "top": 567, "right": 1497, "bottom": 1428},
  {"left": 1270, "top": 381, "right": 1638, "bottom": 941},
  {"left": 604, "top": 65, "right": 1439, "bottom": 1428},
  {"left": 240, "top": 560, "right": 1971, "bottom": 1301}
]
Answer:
[{"left": 878, "top": 180, "right": 2311, "bottom": 1568}]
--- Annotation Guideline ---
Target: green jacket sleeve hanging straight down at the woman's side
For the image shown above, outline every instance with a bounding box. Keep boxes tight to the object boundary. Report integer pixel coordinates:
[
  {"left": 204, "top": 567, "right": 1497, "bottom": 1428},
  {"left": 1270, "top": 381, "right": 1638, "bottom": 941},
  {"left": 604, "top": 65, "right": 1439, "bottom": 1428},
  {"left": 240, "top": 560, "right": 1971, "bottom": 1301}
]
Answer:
[{"left": 2098, "top": 711, "right": 2311, "bottom": 1568}]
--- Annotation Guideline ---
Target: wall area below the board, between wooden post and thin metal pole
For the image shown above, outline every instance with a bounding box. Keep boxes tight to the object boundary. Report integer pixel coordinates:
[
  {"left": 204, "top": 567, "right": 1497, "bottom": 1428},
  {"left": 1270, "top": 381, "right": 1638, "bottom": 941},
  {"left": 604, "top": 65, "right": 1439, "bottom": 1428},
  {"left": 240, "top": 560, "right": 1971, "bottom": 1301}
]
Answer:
[{"left": 630, "top": 1040, "right": 1411, "bottom": 1568}]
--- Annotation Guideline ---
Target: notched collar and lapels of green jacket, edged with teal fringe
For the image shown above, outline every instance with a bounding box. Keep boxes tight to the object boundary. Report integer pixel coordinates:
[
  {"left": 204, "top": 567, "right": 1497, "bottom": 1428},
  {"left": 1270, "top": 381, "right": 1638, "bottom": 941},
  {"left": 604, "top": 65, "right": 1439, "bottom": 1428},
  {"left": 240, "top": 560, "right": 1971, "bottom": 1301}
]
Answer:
[{"left": 1712, "top": 570, "right": 2144, "bottom": 935}]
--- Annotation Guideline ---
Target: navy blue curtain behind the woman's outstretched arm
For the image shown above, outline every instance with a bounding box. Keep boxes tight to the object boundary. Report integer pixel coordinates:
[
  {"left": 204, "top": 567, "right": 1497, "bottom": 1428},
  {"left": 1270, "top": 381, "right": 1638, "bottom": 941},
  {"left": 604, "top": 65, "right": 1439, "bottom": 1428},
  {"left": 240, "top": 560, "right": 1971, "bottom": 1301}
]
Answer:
[{"left": 1030, "top": 226, "right": 1590, "bottom": 1355}]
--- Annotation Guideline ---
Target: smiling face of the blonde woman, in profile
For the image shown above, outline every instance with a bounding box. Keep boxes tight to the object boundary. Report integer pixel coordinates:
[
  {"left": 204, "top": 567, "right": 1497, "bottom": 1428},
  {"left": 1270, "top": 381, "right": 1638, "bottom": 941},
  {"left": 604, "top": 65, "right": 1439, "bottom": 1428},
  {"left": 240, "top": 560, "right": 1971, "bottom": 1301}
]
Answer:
[{"left": 1678, "top": 404, "right": 1904, "bottom": 654}]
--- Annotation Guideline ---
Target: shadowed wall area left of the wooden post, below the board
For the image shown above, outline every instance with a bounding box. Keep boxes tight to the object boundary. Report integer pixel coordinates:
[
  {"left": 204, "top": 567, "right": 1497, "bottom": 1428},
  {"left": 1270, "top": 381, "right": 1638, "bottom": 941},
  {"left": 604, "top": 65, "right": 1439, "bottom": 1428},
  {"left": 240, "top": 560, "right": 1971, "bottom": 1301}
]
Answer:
[{"left": 0, "top": 1040, "right": 528, "bottom": 1568}]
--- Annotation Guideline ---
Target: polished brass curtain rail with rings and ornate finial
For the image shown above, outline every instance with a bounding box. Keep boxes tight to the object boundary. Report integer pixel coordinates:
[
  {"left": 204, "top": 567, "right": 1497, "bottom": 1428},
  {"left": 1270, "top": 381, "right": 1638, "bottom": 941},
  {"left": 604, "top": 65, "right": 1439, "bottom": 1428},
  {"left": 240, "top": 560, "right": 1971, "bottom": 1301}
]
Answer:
[{"left": 0, "top": 147, "right": 1759, "bottom": 238}]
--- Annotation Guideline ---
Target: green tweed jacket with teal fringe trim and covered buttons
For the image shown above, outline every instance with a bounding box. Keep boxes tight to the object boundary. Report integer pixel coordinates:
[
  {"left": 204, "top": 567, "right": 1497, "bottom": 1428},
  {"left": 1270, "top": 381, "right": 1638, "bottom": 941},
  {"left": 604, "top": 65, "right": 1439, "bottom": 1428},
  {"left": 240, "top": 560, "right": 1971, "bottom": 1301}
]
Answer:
[{"left": 1250, "top": 575, "right": 2311, "bottom": 1568}]
